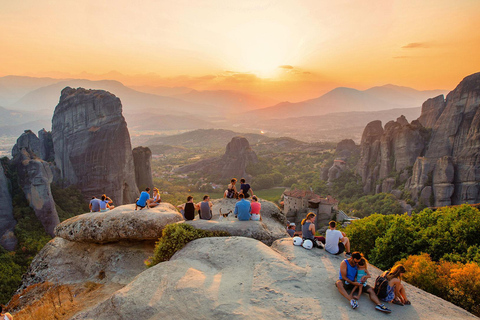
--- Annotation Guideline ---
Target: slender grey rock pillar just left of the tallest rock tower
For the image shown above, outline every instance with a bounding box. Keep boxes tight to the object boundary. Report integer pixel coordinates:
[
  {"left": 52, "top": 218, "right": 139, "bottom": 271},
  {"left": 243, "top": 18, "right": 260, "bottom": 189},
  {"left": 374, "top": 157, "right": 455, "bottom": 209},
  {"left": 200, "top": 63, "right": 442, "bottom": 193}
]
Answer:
[{"left": 12, "top": 130, "right": 60, "bottom": 236}]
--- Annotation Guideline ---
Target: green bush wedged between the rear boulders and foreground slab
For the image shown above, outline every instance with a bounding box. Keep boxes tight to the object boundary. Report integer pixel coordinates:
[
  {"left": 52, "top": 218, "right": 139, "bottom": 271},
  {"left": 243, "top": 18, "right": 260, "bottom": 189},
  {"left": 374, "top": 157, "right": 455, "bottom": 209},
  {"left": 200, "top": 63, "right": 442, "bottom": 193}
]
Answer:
[{"left": 146, "top": 223, "right": 230, "bottom": 267}]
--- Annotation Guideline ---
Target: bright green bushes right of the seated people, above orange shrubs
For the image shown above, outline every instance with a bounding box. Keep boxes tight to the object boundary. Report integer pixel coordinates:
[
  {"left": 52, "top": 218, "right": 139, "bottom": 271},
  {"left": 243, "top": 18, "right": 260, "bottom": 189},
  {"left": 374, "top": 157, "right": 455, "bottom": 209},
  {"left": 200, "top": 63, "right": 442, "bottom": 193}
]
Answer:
[{"left": 345, "top": 205, "right": 480, "bottom": 269}]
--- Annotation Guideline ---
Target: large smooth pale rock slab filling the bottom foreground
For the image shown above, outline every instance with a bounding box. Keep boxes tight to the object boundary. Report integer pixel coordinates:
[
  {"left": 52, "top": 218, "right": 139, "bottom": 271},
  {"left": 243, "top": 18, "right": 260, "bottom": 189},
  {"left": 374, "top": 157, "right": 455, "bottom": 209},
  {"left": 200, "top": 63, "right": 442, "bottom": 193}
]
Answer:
[{"left": 72, "top": 237, "right": 477, "bottom": 320}]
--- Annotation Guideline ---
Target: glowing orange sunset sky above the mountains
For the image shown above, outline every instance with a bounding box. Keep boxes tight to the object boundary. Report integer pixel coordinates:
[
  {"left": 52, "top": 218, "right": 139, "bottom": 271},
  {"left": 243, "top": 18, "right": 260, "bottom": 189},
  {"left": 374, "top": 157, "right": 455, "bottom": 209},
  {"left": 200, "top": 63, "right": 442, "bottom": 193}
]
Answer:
[{"left": 0, "top": 0, "right": 480, "bottom": 101}]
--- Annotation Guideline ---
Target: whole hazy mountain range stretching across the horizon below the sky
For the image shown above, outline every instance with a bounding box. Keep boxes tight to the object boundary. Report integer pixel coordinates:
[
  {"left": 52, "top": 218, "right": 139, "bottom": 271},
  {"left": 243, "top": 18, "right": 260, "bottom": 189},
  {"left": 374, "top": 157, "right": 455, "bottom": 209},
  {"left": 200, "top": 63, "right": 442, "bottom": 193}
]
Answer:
[{"left": 0, "top": 76, "right": 446, "bottom": 142}]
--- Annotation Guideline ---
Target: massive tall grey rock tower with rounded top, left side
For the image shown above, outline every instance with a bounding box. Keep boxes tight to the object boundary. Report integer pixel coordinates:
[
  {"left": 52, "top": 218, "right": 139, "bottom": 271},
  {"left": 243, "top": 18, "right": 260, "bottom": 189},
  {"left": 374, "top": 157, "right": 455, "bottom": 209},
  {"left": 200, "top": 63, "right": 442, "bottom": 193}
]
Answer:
[{"left": 52, "top": 87, "right": 138, "bottom": 204}]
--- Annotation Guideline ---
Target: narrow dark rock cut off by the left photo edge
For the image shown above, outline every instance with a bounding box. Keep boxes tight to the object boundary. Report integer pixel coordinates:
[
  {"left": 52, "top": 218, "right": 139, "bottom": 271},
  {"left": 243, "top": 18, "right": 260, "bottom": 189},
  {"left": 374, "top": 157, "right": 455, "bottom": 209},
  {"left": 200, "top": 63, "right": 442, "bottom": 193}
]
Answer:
[{"left": 0, "top": 164, "right": 17, "bottom": 251}]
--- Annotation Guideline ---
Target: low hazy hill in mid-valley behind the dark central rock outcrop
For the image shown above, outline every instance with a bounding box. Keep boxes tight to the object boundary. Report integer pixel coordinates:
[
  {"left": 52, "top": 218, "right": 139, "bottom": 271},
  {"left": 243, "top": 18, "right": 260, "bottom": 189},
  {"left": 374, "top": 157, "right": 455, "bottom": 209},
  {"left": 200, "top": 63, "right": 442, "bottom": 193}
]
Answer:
[{"left": 145, "top": 129, "right": 269, "bottom": 149}]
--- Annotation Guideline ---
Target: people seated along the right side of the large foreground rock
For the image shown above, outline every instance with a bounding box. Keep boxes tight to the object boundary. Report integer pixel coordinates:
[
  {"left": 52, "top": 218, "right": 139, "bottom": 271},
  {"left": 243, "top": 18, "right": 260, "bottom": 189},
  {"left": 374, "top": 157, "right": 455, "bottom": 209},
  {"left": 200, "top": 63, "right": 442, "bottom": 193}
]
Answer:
[{"left": 287, "top": 212, "right": 411, "bottom": 313}]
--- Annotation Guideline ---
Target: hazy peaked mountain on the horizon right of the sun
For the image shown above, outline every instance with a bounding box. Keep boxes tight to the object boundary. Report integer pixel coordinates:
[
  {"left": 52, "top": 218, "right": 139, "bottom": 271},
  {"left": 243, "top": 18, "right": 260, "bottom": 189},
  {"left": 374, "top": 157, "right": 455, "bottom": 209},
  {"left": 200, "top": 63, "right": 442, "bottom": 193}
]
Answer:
[{"left": 255, "top": 85, "right": 447, "bottom": 119}]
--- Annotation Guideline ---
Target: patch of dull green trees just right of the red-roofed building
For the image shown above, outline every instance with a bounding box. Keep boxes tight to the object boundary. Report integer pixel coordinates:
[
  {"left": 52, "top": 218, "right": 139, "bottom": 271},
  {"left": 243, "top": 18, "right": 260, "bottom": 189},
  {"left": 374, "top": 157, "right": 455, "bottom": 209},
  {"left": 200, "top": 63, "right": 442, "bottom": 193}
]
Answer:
[{"left": 339, "top": 193, "right": 403, "bottom": 218}]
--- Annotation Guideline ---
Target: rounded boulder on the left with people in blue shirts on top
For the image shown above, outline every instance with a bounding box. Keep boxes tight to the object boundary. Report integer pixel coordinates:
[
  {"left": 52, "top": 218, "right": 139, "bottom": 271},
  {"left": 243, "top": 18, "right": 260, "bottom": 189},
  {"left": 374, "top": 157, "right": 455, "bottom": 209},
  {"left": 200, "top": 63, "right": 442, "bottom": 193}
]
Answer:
[{"left": 55, "top": 203, "right": 183, "bottom": 243}]
